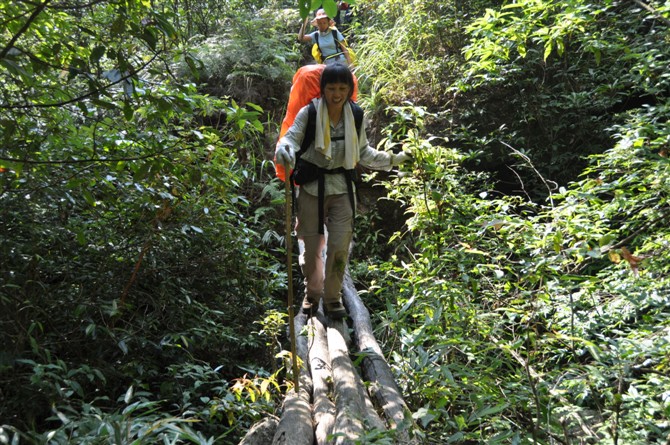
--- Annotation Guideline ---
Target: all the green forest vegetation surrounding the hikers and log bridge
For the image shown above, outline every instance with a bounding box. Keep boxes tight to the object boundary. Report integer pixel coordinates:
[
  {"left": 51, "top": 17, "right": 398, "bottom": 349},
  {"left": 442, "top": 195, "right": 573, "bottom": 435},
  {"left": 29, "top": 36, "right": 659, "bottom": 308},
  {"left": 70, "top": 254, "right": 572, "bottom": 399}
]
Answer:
[{"left": 0, "top": 0, "right": 670, "bottom": 445}]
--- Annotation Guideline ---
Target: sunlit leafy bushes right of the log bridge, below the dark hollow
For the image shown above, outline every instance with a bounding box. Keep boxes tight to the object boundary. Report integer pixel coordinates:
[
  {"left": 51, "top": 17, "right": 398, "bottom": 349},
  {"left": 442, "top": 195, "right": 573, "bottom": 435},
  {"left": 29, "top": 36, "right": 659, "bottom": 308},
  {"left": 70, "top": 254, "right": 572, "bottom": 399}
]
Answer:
[{"left": 357, "top": 89, "right": 670, "bottom": 444}]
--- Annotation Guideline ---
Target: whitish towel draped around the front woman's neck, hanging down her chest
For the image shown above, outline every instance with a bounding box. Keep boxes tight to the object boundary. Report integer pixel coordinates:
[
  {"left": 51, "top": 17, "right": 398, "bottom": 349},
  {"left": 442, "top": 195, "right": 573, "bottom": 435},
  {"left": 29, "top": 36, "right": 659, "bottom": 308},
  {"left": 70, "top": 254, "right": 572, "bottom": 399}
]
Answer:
[{"left": 313, "top": 98, "right": 360, "bottom": 170}]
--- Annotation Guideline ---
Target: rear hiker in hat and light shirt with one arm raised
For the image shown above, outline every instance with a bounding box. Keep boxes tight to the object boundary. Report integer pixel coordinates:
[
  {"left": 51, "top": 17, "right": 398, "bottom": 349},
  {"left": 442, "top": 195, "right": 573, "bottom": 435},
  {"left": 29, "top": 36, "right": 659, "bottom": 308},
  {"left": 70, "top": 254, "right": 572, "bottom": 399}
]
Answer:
[{"left": 298, "top": 9, "right": 351, "bottom": 65}]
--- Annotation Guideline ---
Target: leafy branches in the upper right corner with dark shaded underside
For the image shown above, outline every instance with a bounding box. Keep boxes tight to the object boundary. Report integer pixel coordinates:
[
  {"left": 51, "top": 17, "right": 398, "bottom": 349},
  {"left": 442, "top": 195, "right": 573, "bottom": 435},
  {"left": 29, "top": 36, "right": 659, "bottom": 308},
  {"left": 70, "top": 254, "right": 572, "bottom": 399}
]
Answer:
[{"left": 457, "top": 0, "right": 668, "bottom": 194}]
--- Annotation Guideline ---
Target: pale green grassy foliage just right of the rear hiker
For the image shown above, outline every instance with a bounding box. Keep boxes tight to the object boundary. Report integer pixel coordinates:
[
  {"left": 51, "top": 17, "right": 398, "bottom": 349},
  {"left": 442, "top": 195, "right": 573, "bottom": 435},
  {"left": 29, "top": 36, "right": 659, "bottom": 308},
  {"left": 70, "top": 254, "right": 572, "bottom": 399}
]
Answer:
[{"left": 353, "top": 1, "right": 468, "bottom": 107}]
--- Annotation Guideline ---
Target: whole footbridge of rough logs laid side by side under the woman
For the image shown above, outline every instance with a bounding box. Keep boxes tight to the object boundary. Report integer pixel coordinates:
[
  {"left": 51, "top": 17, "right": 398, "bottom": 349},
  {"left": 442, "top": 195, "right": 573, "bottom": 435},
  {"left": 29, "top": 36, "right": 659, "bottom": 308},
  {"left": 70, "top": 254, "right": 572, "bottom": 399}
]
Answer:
[{"left": 239, "top": 253, "right": 419, "bottom": 445}]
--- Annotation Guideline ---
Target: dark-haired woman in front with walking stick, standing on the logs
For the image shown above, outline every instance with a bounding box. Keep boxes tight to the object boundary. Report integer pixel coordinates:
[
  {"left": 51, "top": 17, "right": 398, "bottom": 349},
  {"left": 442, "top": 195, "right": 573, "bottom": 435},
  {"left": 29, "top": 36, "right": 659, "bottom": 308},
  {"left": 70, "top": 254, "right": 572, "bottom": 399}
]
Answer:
[{"left": 275, "top": 64, "right": 411, "bottom": 319}]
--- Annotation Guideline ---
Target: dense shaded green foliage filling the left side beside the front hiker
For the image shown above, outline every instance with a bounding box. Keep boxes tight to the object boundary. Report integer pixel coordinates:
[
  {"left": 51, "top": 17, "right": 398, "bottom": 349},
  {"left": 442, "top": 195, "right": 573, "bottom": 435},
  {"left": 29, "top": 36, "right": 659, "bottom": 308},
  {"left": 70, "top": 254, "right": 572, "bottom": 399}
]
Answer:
[{"left": 0, "top": 2, "right": 292, "bottom": 443}]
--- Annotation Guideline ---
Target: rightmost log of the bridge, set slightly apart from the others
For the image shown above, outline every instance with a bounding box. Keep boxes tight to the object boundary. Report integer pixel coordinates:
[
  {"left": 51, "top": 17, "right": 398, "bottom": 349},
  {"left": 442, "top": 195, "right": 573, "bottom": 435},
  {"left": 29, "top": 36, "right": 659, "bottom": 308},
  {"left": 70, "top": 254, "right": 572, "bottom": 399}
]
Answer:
[{"left": 342, "top": 270, "right": 417, "bottom": 444}]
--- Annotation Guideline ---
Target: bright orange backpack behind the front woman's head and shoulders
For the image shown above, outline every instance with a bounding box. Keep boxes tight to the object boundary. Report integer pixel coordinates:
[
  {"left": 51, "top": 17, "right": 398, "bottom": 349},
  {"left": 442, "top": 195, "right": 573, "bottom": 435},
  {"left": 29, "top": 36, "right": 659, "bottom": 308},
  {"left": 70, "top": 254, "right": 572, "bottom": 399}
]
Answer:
[{"left": 274, "top": 64, "right": 358, "bottom": 181}]
